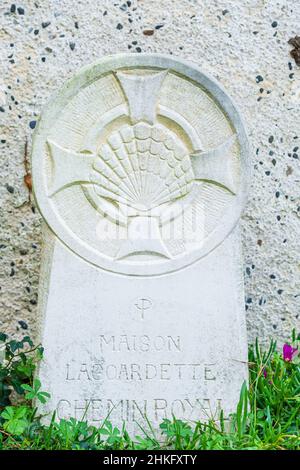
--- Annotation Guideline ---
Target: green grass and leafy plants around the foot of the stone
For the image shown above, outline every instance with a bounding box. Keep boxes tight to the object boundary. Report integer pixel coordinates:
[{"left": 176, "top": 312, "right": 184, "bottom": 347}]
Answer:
[{"left": 0, "top": 332, "right": 300, "bottom": 450}]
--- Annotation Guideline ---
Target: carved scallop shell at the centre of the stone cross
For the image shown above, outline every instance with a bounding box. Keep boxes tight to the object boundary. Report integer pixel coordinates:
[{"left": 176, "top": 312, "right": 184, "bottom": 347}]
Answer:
[{"left": 93, "top": 123, "right": 194, "bottom": 211}]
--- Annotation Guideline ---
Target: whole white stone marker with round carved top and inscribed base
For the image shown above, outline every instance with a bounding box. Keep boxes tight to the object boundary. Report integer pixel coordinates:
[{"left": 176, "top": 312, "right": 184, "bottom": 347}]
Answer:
[{"left": 32, "top": 54, "right": 249, "bottom": 432}]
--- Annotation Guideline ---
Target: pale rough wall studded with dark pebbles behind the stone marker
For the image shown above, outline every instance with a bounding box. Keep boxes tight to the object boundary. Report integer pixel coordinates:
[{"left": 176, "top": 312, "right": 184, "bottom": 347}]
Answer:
[{"left": 0, "top": 0, "right": 300, "bottom": 346}]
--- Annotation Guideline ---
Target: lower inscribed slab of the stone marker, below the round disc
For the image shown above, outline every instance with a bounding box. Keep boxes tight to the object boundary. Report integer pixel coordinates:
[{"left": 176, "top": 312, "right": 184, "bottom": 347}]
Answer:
[{"left": 40, "top": 232, "right": 247, "bottom": 432}]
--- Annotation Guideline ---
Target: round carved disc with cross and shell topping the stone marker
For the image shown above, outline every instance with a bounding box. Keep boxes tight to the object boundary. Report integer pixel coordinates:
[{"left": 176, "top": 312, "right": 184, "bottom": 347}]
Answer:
[{"left": 32, "top": 54, "right": 249, "bottom": 276}]
